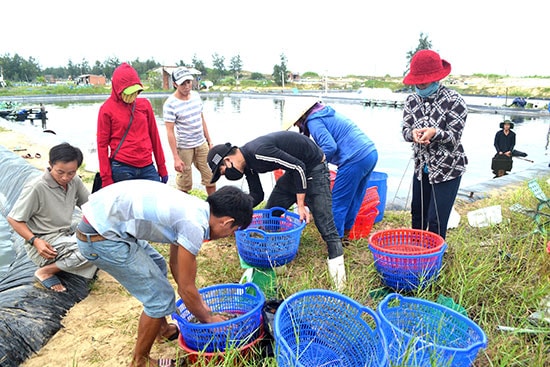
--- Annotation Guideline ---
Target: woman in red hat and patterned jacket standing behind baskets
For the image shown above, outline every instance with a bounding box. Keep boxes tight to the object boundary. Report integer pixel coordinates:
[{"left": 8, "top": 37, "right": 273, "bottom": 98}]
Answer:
[{"left": 402, "top": 50, "right": 468, "bottom": 238}]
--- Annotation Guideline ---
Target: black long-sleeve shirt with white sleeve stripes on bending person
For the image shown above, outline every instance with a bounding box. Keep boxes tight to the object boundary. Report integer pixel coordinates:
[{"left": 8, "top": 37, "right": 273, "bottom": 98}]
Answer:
[{"left": 239, "top": 131, "right": 324, "bottom": 206}]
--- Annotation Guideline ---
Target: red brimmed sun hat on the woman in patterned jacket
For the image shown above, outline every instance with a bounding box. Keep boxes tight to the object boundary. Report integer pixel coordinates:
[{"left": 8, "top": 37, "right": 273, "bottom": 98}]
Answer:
[{"left": 403, "top": 50, "right": 451, "bottom": 85}]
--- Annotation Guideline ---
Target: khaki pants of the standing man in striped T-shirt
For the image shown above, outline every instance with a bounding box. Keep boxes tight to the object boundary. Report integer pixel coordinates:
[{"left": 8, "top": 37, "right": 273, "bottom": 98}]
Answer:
[{"left": 176, "top": 142, "right": 216, "bottom": 192}]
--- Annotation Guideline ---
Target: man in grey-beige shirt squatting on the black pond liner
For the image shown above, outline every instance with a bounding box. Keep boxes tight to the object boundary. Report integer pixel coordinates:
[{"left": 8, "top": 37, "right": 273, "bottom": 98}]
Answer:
[{"left": 7, "top": 143, "right": 97, "bottom": 292}]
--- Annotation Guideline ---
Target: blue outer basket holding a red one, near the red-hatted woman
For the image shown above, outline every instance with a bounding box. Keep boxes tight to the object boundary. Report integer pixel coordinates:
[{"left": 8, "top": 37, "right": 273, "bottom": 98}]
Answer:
[{"left": 369, "top": 243, "right": 447, "bottom": 291}]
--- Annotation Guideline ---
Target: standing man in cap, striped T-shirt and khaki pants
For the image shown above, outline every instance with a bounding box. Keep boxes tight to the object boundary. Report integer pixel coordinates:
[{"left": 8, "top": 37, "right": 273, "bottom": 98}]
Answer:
[{"left": 162, "top": 67, "right": 216, "bottom": 195}]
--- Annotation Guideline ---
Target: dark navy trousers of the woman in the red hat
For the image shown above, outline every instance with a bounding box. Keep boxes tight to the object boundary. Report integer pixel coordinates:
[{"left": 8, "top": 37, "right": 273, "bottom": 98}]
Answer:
[{"left": 411, "top": 172, "right": 462, "bottom": 238}]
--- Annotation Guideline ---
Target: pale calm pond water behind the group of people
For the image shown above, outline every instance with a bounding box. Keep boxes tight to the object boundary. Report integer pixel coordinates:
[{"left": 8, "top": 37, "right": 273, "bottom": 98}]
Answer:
[{"left": 0, "top": 95, "right": 550, "bottom": 274}]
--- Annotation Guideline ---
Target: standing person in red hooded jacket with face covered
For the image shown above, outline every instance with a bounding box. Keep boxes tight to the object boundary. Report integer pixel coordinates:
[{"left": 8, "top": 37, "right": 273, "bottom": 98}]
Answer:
[{"left": 97, "top": 63, "right": 168, "bottom": 187}]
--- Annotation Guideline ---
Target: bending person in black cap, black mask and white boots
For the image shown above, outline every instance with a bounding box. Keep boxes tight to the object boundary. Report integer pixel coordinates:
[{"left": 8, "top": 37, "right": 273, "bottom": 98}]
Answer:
[{"left": 208, "top": 131, "right": 346, "bottom": 290}]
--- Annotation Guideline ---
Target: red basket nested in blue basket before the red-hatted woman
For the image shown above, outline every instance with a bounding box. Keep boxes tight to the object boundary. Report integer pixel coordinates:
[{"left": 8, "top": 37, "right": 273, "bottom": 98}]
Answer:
[{"left": 369, "top": 228, "right": 447, "bottom": 291}]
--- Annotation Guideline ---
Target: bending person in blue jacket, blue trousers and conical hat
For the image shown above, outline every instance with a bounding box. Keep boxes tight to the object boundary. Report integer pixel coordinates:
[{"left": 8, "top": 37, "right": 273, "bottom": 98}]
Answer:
[{"left": 283, "top": 97, "right": 378, "bottom": 241}]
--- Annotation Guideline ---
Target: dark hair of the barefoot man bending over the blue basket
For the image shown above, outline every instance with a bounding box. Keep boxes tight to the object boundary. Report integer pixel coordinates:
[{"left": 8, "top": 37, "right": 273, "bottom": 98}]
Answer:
[{"left": 206, "top": 186, "right": 253, "bottom": 229}]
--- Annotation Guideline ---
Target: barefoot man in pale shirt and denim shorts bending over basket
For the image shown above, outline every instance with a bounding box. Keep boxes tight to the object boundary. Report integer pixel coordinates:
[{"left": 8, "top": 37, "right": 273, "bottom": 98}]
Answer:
[{"left": 76, "top": 180, "right": 253, "bottom": 367}]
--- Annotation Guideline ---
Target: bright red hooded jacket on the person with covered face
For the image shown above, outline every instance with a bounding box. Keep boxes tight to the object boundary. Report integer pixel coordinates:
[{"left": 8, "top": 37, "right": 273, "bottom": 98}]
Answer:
[{"left": 97, "top": 63, "right": 168, "bottom": 187}]
